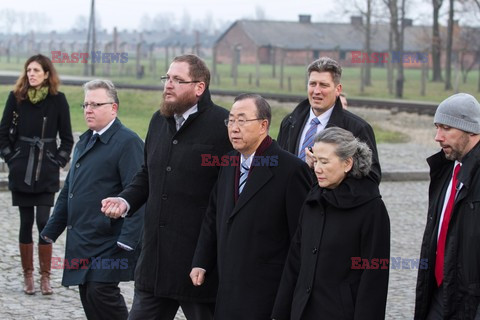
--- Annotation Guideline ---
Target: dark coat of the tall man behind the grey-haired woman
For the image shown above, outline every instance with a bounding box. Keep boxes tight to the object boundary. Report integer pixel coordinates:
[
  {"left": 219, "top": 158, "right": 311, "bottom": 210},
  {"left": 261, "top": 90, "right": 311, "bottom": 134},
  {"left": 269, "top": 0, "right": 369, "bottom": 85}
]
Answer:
[{"left": 278, "top": 98, "right": 382, "bottom": 183}]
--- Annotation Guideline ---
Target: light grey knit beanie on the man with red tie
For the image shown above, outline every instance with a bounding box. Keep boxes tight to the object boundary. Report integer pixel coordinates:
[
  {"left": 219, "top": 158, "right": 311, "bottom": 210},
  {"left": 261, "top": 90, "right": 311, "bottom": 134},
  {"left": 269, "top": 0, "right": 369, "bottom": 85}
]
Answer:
[{"left": 433, "top": 93, "right": 480, "bottom": 134}]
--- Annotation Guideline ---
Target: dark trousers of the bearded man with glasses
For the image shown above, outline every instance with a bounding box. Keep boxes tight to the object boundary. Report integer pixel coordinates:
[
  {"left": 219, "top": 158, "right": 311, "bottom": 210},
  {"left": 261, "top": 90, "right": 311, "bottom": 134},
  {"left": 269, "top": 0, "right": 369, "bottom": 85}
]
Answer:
[{"left": 128, "top": 288, "right": 215, "bottom": 320}]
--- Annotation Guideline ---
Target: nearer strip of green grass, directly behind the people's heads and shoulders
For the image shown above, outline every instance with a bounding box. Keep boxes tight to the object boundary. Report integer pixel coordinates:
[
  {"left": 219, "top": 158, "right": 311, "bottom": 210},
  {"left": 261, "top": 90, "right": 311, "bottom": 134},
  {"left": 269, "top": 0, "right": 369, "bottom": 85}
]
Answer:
[{"left": 0, "top": 85, "right": 406, "bottom": 143}]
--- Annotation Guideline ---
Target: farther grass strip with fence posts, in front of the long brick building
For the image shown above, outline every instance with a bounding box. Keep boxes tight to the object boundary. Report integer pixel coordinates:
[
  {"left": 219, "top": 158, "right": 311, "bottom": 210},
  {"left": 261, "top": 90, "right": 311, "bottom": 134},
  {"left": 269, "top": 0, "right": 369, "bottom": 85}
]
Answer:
[{"left": 0, "top": 56, "right": 479, "bottom": 103}]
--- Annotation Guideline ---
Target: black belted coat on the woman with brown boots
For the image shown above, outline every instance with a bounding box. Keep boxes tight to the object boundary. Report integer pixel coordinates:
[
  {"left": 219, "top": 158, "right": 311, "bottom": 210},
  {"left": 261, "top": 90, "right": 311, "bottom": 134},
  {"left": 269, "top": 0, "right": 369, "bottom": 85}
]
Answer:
[{"left": 0, "top": 92, "right": 73, "bottom": 198}]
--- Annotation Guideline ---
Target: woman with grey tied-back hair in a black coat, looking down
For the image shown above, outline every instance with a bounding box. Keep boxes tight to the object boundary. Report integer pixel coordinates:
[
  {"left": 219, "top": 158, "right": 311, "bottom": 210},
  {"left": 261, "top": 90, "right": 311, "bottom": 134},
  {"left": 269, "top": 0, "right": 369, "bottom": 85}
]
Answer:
[{"left": 272, "top": 128, "right": 390, "bottom": 320}]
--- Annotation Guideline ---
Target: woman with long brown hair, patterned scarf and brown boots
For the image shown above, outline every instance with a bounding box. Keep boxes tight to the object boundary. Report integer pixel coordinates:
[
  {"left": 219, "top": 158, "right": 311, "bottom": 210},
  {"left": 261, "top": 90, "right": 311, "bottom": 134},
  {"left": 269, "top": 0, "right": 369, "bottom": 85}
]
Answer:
[{"left": 0, "top": 54, "right": 73, "bottom": 294}]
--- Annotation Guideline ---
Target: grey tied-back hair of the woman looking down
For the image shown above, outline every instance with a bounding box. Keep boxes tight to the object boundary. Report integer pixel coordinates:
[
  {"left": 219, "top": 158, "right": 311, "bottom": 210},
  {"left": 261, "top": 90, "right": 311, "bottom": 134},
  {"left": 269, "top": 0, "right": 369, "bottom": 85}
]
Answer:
[{"left": 315, "top": 127, "right": 372, "bottom": 179}]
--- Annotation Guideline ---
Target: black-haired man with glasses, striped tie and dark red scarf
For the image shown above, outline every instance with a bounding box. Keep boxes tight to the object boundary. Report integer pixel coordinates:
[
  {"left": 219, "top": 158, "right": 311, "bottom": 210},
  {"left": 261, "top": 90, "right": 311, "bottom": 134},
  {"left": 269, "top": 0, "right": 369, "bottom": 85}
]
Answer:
[{"left": 190, "top": 94, "right": 312, "bottom": 320}]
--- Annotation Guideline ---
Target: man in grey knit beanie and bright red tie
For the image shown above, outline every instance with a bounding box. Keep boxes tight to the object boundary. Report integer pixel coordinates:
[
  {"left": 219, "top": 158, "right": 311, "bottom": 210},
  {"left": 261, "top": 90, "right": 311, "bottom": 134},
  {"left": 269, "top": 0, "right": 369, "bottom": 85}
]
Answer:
[{"left": 415, "top": 93, "right": 480, "bottom": 320}]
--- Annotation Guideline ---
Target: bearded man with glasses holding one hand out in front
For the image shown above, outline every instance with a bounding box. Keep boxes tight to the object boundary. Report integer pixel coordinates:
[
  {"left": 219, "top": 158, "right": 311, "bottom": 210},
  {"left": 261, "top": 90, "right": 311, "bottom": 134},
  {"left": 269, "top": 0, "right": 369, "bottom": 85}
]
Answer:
[{"left": 102, "top": 55, "right": 232, "bottom": 320}]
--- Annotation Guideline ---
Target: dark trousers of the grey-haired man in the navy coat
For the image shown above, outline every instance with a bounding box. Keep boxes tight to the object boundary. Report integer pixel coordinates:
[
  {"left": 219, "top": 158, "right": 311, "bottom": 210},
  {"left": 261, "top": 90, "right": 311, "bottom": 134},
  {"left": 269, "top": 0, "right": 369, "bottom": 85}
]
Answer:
[{"left": 78, "top": 282, "right": 128, "bottom": 320}]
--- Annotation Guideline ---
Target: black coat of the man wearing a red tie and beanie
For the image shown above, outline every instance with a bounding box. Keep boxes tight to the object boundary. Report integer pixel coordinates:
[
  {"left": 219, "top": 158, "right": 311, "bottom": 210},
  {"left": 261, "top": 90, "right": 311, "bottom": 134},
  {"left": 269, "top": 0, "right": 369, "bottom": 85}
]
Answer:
[{"left": 415, "top": 144, "right": 480, "bottom": 320}]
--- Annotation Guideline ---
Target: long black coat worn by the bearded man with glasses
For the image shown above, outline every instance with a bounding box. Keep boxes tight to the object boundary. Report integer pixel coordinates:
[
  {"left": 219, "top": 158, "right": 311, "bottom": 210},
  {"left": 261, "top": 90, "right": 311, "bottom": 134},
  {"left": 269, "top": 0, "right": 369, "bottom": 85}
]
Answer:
[{"left": 119, "top": 90, "right": 232, "bottom": 302}]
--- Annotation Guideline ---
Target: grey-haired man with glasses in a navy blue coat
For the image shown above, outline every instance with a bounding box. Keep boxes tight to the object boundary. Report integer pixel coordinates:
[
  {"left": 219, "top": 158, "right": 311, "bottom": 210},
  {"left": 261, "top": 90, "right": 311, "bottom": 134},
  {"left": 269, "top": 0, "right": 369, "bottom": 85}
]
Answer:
[{"left": 41, "top": 80, "right": 144, "bottom": 320}]
